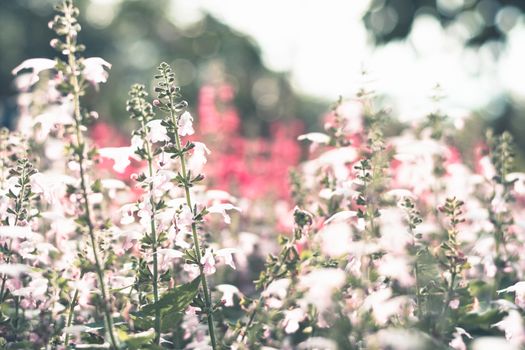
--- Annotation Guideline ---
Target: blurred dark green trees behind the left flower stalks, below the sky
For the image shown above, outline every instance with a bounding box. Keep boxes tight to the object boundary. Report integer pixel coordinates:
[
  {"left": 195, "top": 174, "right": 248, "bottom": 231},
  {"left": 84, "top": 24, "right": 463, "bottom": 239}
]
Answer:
[{"left": 0, "top": 0, "right": 326, "bottom": 136}]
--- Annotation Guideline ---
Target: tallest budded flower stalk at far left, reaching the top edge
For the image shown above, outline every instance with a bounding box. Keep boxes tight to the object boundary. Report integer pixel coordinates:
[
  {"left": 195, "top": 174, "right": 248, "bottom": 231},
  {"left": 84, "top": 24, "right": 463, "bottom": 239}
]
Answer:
[{"left": 49, "top": 0, "right": 118, "bottom": 349}]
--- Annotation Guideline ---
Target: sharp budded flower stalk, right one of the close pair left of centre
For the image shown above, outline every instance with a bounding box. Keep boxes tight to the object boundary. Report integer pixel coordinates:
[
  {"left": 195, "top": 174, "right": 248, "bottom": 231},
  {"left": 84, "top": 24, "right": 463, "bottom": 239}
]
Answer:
[{"left": 155, "top": 62, "right": 219, "bottom": 350}]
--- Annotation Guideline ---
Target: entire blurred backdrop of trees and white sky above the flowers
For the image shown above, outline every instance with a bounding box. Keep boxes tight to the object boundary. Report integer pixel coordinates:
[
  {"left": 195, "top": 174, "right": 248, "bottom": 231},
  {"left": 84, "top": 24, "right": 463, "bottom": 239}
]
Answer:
[{"left": 0, "top": 0, "right": 525, "bottom": 156}]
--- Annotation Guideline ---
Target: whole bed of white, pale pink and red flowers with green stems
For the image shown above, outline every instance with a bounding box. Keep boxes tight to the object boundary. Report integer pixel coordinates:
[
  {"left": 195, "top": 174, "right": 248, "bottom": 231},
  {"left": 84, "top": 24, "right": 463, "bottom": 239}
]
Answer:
[{"left": 0, "top": 0, "right": 525, "bottom": 350}]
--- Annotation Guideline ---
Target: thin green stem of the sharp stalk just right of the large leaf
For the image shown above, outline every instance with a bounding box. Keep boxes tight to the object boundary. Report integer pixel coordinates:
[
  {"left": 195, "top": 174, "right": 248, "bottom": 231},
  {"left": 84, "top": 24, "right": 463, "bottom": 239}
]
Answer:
[{"left": 166, "top": 99, "right": 219, "bottom": 350}]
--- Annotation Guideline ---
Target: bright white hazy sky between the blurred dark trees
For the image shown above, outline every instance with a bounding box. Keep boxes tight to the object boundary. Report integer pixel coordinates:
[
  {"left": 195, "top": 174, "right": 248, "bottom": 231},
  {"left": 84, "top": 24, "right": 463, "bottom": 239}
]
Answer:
[{"left": 88, "top": 0, "right": 525, "bottom": 119}]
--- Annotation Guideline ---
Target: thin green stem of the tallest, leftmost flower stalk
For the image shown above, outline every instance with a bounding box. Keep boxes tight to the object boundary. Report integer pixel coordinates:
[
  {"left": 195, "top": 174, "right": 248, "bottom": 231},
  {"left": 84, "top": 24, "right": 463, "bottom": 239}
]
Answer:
[{"left": 66, "top": 12, "right": 118, "bottom": 349}]
